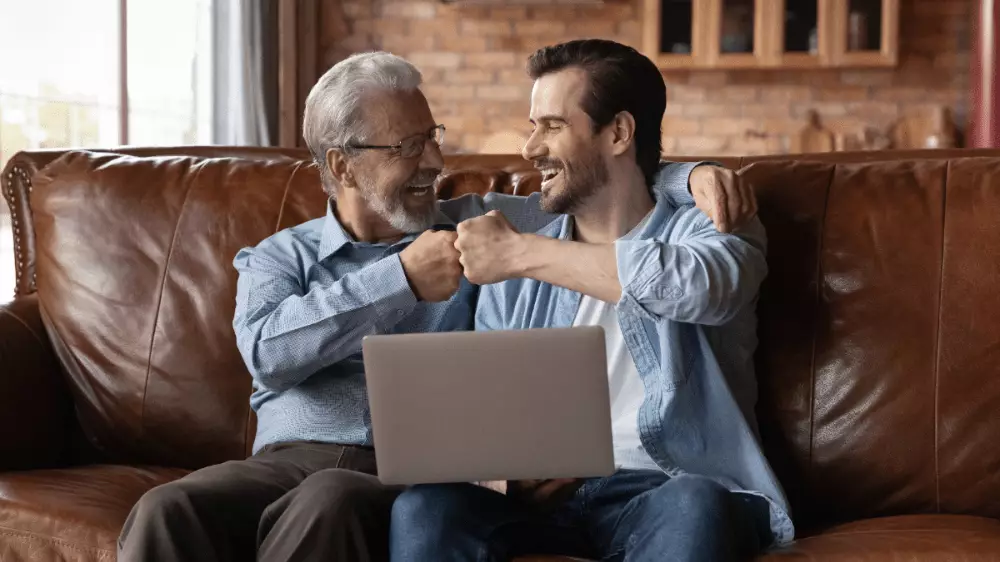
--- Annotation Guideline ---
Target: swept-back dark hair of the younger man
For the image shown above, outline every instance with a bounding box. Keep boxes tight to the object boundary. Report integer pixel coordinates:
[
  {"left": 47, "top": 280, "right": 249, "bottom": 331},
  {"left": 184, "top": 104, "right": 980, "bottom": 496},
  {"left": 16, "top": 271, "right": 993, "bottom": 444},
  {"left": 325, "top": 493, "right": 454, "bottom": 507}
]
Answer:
[{"left": 528, "top": 39, "right": 667, "bottom": 186}]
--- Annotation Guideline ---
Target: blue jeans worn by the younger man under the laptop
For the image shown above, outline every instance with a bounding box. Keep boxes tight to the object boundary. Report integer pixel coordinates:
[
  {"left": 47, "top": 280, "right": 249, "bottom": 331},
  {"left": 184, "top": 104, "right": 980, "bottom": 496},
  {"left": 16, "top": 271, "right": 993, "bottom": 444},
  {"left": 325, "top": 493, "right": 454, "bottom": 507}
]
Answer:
[{"left": 389, "top": 470, "right": 772, "bottom": 562}]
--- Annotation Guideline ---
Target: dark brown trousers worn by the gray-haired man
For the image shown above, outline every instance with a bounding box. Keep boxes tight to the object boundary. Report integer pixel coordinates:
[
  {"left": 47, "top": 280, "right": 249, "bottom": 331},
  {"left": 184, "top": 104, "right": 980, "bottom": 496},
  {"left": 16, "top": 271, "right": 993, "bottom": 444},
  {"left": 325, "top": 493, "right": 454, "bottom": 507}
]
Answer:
[{"left": 118, "top": 443, "right": 401, "bottom": 562}]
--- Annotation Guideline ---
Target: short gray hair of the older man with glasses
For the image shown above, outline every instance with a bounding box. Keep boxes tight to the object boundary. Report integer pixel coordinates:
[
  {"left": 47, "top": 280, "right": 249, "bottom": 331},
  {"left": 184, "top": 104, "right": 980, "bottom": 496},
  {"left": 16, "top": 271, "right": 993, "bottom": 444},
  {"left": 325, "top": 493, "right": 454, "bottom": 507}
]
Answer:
[{"left": 302, "top": 51, "right": 423, "bottom": 197}]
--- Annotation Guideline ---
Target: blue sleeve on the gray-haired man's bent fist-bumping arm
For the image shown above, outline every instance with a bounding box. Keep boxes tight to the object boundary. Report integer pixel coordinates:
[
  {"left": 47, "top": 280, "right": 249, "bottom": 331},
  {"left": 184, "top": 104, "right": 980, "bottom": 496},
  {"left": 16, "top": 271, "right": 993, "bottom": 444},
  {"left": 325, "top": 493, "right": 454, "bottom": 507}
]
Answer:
[{"left": 233, "top": 249, "right": 417, "bottom": 391}]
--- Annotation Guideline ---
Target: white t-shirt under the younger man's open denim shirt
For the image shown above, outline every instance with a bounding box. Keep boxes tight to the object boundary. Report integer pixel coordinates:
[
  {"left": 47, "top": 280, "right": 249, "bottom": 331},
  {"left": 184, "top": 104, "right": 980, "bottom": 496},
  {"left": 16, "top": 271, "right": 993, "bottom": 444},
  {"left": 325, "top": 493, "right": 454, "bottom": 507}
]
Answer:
[{"left": 573, "top": 295, "right": 659, "bottom": 470}]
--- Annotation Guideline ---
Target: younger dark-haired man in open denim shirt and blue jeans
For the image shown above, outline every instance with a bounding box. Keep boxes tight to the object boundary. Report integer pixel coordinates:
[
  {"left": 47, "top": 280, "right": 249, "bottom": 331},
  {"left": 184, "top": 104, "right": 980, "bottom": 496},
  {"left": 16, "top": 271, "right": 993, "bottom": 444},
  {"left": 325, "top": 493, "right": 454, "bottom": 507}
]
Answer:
[{"left": 391, "top": 40, "right": 793, "bottom": 562}]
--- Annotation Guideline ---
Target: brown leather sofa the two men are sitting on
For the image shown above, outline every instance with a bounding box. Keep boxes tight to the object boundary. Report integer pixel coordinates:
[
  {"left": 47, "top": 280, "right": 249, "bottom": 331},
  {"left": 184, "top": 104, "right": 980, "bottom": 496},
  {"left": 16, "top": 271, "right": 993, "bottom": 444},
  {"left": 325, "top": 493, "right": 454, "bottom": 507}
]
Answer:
[{"left": 0, "top": 147, "right": 1000, "bottom": 562}]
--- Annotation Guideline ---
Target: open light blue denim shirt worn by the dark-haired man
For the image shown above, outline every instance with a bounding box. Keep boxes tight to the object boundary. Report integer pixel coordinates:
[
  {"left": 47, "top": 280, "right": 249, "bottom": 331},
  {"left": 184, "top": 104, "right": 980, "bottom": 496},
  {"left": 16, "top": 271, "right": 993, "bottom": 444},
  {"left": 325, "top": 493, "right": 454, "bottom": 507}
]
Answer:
[{"left": 476, "top": 167, "right": 794, "bottom": 544}]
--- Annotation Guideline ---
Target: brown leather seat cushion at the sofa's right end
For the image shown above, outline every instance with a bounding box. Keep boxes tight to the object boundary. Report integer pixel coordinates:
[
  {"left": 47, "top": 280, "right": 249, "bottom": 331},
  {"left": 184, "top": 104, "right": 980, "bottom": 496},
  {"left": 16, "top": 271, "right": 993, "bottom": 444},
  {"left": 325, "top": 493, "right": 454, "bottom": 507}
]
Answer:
[{"left": 758, "top": 515, "right": 1000, "bottom": 562}]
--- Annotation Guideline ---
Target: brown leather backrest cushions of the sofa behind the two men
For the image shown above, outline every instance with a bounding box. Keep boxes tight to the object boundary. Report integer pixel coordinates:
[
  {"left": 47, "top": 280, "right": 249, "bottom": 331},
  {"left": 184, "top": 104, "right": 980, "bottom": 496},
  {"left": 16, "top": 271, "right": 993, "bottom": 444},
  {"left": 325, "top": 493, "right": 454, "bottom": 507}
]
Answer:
[{"left": 8, "top": 147, "right": 1000, "bottom": 526}]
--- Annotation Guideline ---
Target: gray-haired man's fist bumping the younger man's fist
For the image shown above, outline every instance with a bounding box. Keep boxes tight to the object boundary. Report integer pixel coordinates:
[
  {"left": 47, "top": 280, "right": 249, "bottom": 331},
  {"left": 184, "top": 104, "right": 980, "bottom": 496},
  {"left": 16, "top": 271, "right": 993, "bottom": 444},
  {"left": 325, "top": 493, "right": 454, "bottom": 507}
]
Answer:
[{"left": 399, "top": 230, "right": 462, "bottom": 302}]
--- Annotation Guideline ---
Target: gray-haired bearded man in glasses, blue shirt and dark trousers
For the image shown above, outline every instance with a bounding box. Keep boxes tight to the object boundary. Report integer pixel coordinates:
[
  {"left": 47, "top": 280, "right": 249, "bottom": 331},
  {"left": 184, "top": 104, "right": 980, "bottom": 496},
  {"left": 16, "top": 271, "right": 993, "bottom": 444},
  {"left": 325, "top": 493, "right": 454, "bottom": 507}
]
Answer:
[{"left": 119, "top": 49, "right": 751, "bottom": 562}]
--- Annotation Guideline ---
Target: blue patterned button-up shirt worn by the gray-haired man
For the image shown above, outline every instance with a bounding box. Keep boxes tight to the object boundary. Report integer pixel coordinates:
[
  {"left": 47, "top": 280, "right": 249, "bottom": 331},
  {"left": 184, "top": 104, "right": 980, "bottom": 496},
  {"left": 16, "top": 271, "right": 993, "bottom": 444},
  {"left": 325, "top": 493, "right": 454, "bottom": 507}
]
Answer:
[{"left": 233, "top": 163, "right": 697, "bottom": 452}]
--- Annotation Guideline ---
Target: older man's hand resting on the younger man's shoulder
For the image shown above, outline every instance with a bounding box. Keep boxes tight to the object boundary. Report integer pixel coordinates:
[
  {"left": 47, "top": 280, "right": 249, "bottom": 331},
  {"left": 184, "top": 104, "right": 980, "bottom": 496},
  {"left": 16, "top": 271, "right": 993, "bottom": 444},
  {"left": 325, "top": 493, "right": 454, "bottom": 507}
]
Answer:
[{"left": 688, "top": 165, "right": 757, "bottom": 232}]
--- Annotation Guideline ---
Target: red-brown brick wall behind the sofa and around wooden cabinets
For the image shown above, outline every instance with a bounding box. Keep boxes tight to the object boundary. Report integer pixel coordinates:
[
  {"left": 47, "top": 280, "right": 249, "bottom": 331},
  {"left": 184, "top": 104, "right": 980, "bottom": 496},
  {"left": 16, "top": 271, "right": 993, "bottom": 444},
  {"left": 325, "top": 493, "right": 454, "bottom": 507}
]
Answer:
[{"left": 321, "top": 0, "right": 973, "bottom": 155}]
